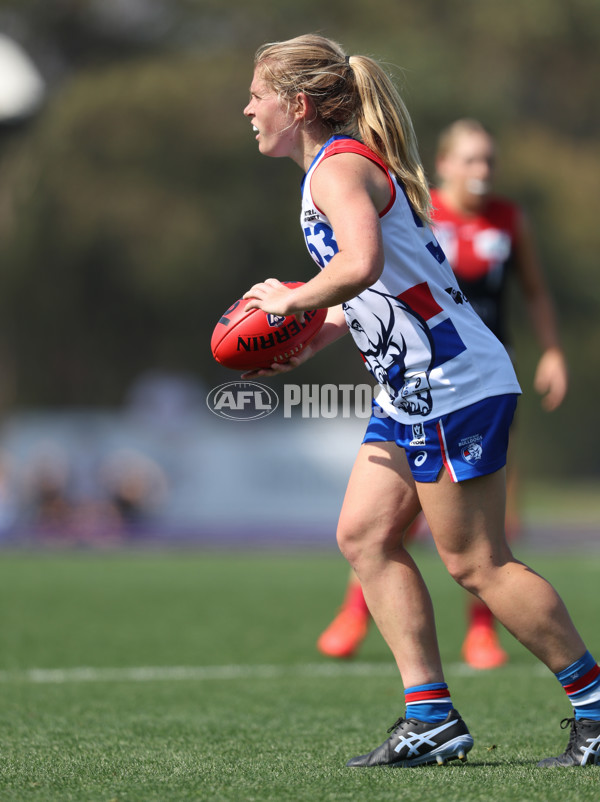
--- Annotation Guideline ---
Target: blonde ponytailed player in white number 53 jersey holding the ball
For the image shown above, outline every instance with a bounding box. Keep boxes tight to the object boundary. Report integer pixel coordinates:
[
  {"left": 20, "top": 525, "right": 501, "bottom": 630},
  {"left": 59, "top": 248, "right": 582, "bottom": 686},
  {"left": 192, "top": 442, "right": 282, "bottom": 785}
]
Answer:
[{"left": 244, "top": 35, "right": 600, "bottom": 766}]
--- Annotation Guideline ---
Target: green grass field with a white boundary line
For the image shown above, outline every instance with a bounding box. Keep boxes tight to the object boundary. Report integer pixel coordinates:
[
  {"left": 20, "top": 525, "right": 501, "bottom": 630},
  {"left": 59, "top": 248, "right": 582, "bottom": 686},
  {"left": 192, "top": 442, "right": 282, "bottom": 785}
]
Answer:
[{"left": 0, "top": 547, "right": 600, "bottom": 802}]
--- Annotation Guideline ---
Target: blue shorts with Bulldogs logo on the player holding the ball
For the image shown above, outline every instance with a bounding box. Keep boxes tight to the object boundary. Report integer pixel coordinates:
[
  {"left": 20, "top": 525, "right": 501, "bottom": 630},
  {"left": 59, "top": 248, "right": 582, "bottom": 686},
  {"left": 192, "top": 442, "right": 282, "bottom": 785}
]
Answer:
[{"left": 363, "top": 393, "right": 518, "bottom": 482}]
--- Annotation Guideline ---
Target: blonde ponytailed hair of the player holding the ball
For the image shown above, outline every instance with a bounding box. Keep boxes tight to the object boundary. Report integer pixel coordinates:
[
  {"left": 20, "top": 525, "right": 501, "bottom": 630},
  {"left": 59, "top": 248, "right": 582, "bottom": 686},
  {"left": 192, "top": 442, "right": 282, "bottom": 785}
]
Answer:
[{"left": 254, "top": 34, "right": 431, "bottom": 222}]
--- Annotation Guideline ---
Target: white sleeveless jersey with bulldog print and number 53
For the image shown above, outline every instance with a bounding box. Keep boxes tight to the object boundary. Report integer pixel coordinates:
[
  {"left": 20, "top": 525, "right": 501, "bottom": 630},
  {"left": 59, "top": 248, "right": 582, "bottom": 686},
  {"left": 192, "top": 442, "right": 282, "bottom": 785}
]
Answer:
[{"left": 301, "top": 136, "right": 521, "bottom": 423}]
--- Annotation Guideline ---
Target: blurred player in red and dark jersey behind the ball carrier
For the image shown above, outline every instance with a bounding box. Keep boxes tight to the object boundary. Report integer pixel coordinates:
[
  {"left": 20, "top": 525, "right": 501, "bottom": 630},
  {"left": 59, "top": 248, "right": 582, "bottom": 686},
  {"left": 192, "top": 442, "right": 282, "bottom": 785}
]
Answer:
[{"left": 317, "top": 119, "right": 568, "bottom": 669}]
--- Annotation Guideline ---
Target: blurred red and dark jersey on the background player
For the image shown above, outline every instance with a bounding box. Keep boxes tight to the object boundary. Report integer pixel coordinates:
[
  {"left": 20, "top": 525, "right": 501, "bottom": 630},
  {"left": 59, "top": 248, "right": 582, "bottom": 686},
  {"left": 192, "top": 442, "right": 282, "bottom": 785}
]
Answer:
[{"left": 431, "top": 189, "right": 521, "bottom": 345}]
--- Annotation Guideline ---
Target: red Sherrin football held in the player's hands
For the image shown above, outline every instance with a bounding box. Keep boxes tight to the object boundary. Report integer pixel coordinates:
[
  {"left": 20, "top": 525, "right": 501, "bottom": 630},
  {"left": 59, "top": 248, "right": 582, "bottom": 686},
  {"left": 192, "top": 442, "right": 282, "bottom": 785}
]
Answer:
[{"left": 210, "top": 281, "right": 327, "bottom": 371}]
